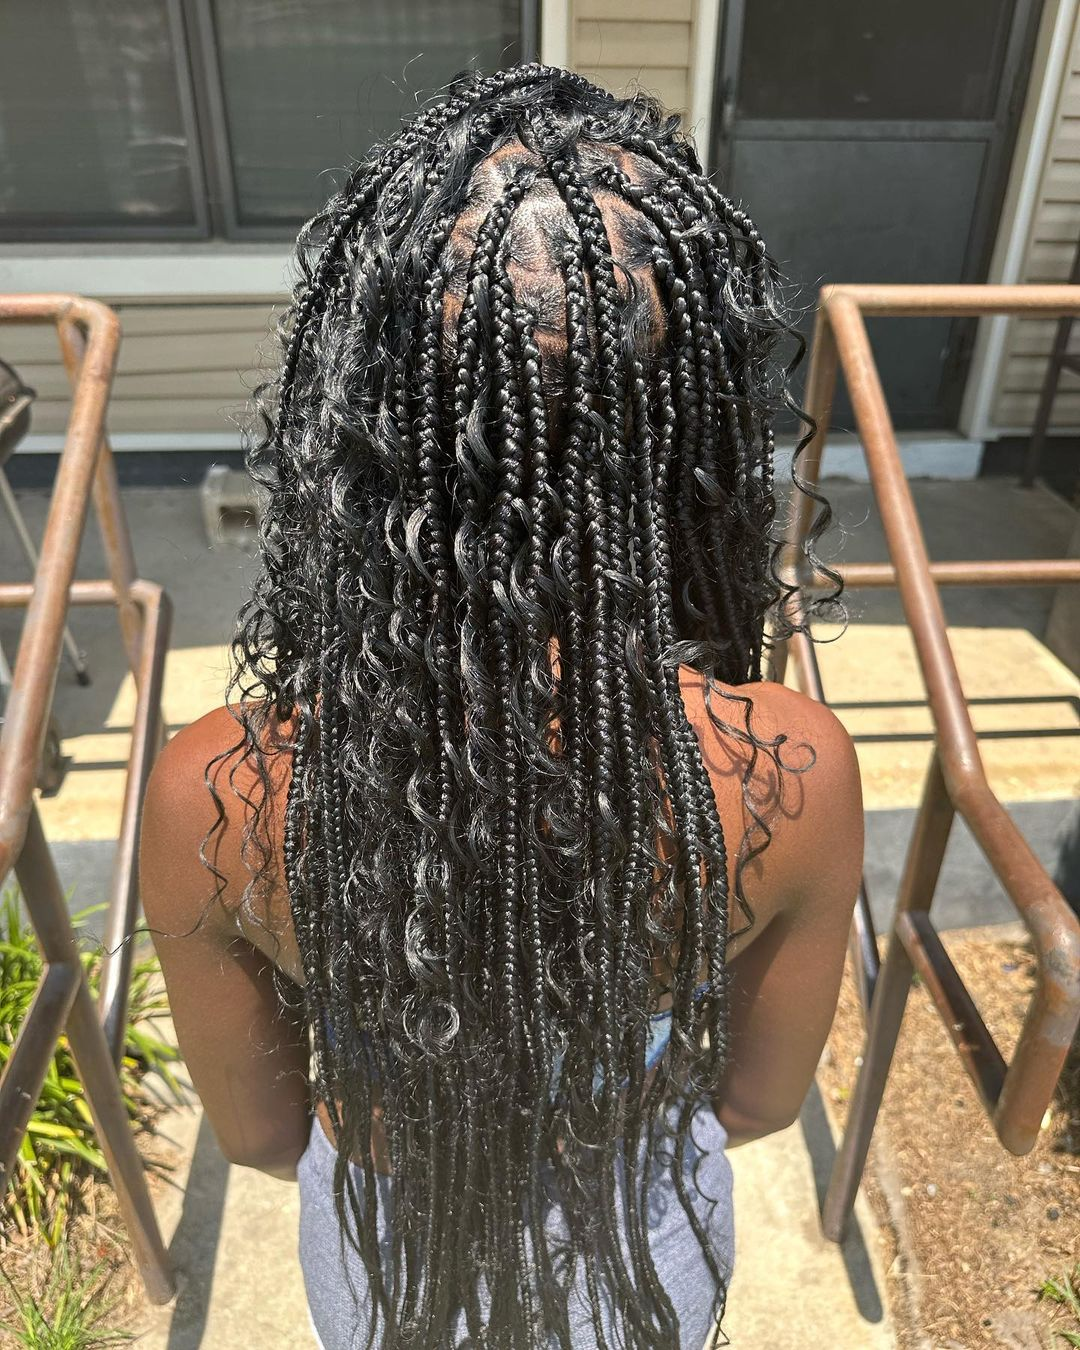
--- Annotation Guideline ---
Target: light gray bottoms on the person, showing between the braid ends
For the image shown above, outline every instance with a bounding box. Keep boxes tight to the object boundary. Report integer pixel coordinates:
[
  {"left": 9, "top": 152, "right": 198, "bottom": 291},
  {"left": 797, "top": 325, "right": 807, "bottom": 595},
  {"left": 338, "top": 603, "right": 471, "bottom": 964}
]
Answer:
[{"left": 297, "top": 1102, "right": 734, "bottom": 1350}]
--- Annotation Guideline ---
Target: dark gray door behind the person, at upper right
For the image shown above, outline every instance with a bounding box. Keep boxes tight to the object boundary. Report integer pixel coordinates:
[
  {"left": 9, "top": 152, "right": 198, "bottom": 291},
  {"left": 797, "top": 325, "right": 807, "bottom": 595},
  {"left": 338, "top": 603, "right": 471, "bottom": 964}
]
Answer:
[{"left": 711, "top": 0, "right": 1041, "bottom": 429}]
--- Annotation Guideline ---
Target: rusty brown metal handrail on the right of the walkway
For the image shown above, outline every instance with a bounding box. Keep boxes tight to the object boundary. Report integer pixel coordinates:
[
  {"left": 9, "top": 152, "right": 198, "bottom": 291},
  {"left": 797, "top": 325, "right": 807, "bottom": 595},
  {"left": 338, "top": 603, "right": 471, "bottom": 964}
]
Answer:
[{"left": 776, "top": 286, "right": 1080, "bottom": 1241}]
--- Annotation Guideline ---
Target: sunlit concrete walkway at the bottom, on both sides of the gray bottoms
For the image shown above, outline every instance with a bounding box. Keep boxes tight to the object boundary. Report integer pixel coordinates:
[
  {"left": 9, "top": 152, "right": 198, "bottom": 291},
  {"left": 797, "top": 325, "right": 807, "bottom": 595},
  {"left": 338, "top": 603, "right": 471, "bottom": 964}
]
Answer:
[{"left": 138, "top": 1089, "right": 896, "bottom": 1350}]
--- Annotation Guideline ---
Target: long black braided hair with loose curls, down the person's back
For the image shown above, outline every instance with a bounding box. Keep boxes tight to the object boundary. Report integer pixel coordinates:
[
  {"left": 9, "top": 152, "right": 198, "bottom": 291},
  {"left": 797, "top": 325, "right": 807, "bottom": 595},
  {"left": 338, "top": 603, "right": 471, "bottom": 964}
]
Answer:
[{"left": 213, "top": 65, "right": 824, "bottom": 1350}]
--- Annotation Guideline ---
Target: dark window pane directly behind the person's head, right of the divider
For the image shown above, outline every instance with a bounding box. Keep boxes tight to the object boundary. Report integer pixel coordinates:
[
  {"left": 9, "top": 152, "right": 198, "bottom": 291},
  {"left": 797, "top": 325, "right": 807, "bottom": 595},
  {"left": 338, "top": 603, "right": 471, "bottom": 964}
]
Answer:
[{"left": 213, "top": 0, "right": 521, "bottom": 227}]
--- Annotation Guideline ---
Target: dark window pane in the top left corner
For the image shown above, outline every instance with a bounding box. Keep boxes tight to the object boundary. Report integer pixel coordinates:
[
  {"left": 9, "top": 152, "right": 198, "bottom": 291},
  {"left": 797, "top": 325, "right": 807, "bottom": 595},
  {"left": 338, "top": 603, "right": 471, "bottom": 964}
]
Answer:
[{"left": 0, "top": 0, "right": 196, "bottom": 235}]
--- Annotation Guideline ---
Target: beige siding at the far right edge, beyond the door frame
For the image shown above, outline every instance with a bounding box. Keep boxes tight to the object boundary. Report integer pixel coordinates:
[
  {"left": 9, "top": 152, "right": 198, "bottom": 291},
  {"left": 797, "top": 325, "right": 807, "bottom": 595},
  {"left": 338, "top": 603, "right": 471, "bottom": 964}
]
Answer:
[{"left": 991, "top": 0, "right": 1080, "bottom": 433}]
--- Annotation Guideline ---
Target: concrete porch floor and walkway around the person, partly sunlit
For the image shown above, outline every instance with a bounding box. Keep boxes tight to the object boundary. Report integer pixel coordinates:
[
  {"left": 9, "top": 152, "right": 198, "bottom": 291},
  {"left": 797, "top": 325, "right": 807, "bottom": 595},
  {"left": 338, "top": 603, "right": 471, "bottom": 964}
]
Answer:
[{"left": 0, "top": 469, "right": 1080, "bottom": 1350}]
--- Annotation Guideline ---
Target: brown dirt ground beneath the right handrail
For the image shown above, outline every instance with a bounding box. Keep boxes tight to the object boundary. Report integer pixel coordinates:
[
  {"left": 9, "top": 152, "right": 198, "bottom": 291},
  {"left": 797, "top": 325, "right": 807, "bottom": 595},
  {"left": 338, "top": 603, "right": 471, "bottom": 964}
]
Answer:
[{"left": 819, "top": 927, "right": 1080, "bottom": 1350}]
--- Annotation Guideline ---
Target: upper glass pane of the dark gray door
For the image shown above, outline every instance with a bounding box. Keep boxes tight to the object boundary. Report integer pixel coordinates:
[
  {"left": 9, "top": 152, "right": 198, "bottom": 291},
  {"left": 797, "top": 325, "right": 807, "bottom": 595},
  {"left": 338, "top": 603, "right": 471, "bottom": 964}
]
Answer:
[{"left": 738, "top": 0, "right": 1015, "bottom": 122}]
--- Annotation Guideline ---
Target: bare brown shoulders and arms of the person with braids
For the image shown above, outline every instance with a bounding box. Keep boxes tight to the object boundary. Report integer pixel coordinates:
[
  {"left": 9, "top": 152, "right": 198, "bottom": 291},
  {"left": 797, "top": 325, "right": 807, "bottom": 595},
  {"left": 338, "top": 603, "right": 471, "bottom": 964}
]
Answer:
[{"left": 139, "top": 668, "right": 863, "bottom": 1180}]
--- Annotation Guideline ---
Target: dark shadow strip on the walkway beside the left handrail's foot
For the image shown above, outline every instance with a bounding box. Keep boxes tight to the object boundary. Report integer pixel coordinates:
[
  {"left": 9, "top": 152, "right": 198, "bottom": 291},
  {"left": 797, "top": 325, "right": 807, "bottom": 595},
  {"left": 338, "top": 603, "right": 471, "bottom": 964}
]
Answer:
[{"left": 167, "top": 1115, "right": 228, "bottom": 1350}]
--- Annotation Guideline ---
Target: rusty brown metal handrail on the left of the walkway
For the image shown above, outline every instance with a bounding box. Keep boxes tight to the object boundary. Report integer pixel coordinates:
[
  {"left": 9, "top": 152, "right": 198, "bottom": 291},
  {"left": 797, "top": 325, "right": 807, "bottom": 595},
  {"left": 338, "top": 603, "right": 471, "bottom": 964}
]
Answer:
[{"left": 0, "top": 294, "right": 174, "bottom": 1303}]
